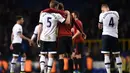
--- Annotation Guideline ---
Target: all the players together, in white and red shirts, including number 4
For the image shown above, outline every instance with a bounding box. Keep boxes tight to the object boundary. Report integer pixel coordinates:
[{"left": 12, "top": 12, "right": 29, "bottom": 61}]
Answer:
[{"left": 10, "top": 1, "right": 122, "bottom": 73}]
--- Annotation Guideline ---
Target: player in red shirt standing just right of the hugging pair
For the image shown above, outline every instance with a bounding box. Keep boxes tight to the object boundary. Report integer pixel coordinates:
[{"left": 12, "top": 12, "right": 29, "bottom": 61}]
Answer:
[{"left": 72, "top": 11, "right": 84, "bottom": 72}]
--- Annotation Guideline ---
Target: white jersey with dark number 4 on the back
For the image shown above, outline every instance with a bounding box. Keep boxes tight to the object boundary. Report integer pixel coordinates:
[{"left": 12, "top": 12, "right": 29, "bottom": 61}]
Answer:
[{"left": 99, "top": 11, "right": 119, "bottom": 38}]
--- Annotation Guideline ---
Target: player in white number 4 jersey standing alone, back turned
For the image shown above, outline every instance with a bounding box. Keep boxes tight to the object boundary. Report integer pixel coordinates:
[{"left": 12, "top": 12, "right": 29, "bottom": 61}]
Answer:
[{"left": 98, "top": 4, "right": 122, "bottom": 73}]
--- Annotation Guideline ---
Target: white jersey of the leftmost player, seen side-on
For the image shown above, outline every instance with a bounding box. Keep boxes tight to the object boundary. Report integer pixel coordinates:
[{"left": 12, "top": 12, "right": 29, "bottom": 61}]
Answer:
[{"left": 12, "top": 24, "right": 23, "bottom": 44}]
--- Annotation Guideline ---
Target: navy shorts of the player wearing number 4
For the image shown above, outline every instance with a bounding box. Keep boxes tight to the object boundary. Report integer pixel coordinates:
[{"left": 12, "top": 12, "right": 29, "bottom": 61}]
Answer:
[{"left": 101, "top": 35, "right": 120, "bottom": 54}]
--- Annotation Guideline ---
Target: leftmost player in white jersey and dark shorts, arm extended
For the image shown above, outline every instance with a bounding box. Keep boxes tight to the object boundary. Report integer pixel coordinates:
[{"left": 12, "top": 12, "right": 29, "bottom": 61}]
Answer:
[{"left": 10, "top": 16, "right": 32, "bottom": 73}]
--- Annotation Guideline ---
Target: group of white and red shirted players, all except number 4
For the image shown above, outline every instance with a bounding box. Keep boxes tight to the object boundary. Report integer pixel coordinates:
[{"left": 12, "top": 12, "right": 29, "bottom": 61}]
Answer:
[{"left": 10, "top": 1, "right": 86, "bottom": 73}]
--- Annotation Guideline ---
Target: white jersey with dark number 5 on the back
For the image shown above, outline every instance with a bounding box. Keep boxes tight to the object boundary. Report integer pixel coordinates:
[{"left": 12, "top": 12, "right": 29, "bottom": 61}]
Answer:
[{"left": 39, "top": 12, "right": 65, "bottom": 42}]
